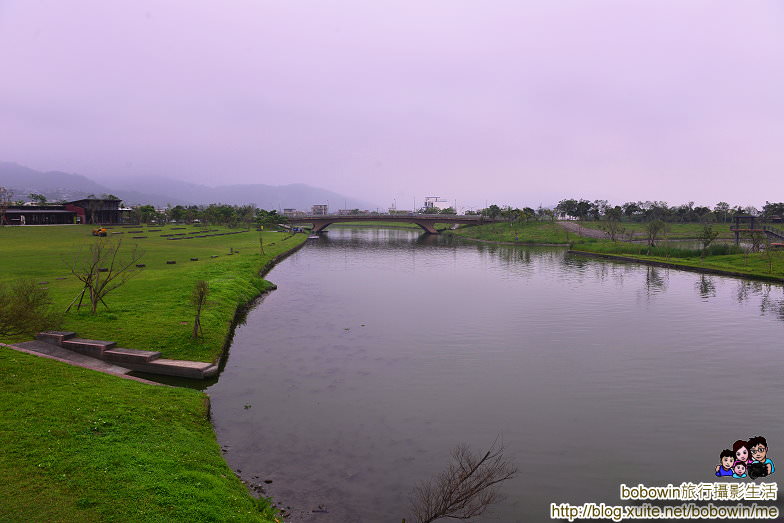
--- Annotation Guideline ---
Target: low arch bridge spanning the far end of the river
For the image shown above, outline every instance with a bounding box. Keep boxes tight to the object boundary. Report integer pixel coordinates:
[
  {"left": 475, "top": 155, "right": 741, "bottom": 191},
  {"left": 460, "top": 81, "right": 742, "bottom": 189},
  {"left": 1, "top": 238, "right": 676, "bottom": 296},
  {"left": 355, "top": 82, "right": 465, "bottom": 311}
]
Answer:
[{"left": 288, "top": 213, "right": 502, "bottom": 234}]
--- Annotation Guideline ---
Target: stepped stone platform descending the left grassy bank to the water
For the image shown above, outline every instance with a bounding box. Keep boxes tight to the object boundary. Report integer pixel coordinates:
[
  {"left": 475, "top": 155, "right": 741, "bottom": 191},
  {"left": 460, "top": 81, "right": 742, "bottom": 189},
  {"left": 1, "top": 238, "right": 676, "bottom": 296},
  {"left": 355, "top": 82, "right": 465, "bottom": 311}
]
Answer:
[{"left": 31, "top": 331, "right": 218, "bottom": 379}]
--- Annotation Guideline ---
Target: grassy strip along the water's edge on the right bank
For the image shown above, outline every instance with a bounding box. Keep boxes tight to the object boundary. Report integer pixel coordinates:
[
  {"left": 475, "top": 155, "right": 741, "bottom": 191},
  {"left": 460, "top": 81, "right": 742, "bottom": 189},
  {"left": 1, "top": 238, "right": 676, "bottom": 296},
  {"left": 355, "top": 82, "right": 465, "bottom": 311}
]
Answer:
[{"left": 572, "top": 240, "right": 784, "bottom": 280}]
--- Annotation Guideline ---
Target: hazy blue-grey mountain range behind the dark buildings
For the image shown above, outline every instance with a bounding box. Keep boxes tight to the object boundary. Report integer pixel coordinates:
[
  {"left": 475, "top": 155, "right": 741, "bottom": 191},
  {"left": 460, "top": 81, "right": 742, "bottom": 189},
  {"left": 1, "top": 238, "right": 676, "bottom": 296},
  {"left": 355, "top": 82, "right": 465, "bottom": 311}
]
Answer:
[{"left": 0, "top": 162, "right": 377, "bottom": 210}]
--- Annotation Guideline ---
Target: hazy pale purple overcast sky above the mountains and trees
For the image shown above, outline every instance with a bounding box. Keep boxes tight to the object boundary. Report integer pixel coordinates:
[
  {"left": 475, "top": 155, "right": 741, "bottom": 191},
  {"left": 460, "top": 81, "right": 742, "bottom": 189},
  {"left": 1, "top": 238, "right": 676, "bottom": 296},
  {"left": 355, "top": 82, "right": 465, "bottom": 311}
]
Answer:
[{"left": 0, "top": 0, "right": 784, "bottom": 208}]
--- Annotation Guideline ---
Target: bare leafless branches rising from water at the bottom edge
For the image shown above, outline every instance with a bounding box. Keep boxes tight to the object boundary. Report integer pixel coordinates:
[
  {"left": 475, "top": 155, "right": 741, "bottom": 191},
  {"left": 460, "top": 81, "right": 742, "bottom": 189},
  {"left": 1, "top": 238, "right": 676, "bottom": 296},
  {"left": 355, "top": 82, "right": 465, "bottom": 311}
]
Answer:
[{"left": 404, "top": 441, "right": 517, "bottom": 523}]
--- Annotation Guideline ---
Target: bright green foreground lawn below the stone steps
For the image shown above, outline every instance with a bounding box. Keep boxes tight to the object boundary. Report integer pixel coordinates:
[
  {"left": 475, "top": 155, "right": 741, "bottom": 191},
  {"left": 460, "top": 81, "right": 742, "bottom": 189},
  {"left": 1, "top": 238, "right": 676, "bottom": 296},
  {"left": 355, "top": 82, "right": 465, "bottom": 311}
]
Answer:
[{"left": 0, "top": 347, "right": 275, "bottom": 522}]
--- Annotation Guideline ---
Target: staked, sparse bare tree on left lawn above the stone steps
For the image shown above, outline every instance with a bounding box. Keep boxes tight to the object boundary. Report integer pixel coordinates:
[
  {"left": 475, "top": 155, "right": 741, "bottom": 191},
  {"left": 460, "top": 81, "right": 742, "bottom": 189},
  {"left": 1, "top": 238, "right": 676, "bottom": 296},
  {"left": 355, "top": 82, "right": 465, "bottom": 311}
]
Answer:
[{"left": 66, "top": 238, "right": 144, "bottom": 314}]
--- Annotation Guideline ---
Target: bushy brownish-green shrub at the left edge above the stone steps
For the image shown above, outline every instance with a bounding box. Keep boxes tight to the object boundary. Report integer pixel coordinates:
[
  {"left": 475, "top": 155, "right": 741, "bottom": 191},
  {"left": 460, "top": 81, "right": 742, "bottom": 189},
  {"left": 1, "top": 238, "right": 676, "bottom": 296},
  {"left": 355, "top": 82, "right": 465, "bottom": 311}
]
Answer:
[{"left": 0, "top": 280, "right": 62, "bottom": 336}]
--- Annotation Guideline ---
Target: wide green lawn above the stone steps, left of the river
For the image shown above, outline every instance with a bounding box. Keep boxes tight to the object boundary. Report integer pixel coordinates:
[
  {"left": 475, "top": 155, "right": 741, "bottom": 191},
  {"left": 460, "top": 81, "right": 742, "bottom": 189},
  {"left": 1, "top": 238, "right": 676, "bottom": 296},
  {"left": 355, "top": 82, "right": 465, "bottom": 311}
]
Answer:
[{"left": 0, "top": 225, "right": 306, "bottom": 362}]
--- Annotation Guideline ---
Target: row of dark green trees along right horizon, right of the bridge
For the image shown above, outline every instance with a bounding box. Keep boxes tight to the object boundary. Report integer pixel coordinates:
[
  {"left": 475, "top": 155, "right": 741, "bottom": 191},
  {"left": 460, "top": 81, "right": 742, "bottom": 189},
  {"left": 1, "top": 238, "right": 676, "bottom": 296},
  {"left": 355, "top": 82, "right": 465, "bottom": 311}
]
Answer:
[{"left": 555, "top": 198, "right": 784, "bottom": 223}]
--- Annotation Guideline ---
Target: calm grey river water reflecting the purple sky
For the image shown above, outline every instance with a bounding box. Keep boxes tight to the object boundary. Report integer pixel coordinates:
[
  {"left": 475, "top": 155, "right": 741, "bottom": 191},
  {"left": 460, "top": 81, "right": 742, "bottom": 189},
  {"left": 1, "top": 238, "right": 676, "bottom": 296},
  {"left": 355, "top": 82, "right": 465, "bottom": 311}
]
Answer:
[{"left": 207, "top": 228, "right": 784, "bottom": 522}]
